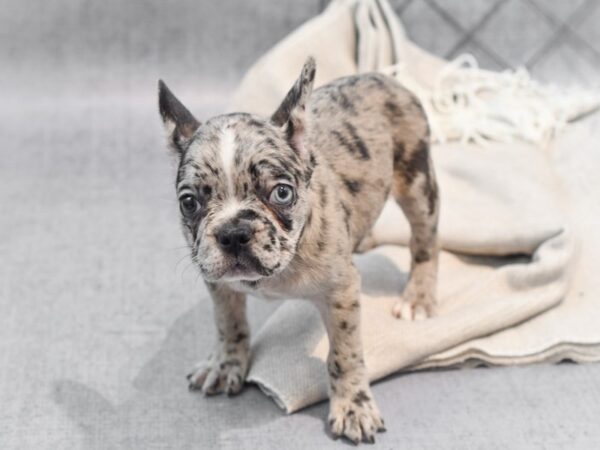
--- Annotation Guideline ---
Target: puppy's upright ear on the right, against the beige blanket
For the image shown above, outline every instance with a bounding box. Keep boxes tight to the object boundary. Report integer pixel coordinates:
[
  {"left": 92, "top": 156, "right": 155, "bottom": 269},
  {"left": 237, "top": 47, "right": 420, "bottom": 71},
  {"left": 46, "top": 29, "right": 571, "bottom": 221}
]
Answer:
[{"left": 271, "top": 56, "right": 316, "bottom": 157}]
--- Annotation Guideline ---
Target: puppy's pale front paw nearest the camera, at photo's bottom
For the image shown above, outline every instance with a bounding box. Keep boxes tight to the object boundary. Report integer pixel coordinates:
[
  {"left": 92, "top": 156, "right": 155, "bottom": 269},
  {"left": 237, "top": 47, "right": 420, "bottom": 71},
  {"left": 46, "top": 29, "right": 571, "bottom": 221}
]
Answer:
[{"left": 329, "top": 390, "right": 385, "bottom": 444}]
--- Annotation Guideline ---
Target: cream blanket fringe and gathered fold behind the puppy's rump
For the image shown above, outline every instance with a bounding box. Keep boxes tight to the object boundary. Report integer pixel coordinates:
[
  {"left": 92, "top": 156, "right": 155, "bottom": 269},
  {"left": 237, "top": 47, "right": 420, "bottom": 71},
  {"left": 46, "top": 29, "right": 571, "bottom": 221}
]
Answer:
[{"left": 355, "top": 0, "right": 600, "bottom": 146}]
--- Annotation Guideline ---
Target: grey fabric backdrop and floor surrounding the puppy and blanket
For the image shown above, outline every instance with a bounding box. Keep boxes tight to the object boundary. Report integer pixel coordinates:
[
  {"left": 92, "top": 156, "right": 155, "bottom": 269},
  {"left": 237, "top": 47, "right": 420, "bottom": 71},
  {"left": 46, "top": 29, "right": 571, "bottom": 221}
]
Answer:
[{"left": 0, "top": 0, "right": 600, "bottom": 449}]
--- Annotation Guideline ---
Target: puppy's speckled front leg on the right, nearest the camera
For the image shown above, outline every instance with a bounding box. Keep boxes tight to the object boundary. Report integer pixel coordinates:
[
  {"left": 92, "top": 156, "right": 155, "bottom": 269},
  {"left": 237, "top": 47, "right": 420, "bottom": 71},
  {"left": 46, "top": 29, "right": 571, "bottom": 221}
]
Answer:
[{"left": 318, "top": 266, "right": 385, "bottom": 444}]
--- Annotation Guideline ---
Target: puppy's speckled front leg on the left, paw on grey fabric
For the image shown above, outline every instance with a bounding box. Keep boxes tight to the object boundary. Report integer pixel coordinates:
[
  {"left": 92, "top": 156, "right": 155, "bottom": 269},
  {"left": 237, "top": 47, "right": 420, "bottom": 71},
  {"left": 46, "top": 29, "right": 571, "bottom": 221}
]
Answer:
[{"left": 188, "top": 283, "right": 250, "bottom": 394}]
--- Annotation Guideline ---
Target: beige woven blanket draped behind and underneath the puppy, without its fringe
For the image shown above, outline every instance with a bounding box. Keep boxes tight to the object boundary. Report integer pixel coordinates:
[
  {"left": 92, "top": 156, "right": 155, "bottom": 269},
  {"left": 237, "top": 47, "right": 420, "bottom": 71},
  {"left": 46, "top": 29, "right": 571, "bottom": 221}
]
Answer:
[{"left": 227, "top": 0, "right": 600, "bottom": 412}]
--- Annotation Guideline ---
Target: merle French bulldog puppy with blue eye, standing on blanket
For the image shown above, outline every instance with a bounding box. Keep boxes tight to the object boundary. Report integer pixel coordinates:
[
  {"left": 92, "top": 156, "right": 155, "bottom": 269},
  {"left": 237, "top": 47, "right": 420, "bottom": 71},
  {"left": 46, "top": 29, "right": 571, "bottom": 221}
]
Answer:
[{"left": 159, "top": 58, "right": 439, "bottom": 443}]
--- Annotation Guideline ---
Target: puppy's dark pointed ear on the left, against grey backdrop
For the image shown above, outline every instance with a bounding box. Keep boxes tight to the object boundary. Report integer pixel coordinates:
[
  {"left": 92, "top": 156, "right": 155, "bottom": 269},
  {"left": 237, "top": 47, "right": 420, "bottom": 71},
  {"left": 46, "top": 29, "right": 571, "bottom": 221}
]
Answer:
[{"left": 158, "top": 80, "right": 200, "bottom": 154}]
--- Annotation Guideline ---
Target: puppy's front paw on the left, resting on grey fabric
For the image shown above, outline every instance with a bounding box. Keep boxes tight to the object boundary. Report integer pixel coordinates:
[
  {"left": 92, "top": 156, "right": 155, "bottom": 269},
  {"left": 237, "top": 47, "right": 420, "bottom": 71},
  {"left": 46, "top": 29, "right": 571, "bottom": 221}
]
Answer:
[{"left": 187, "top": 352, "right": 249, "bottom": 395}]
